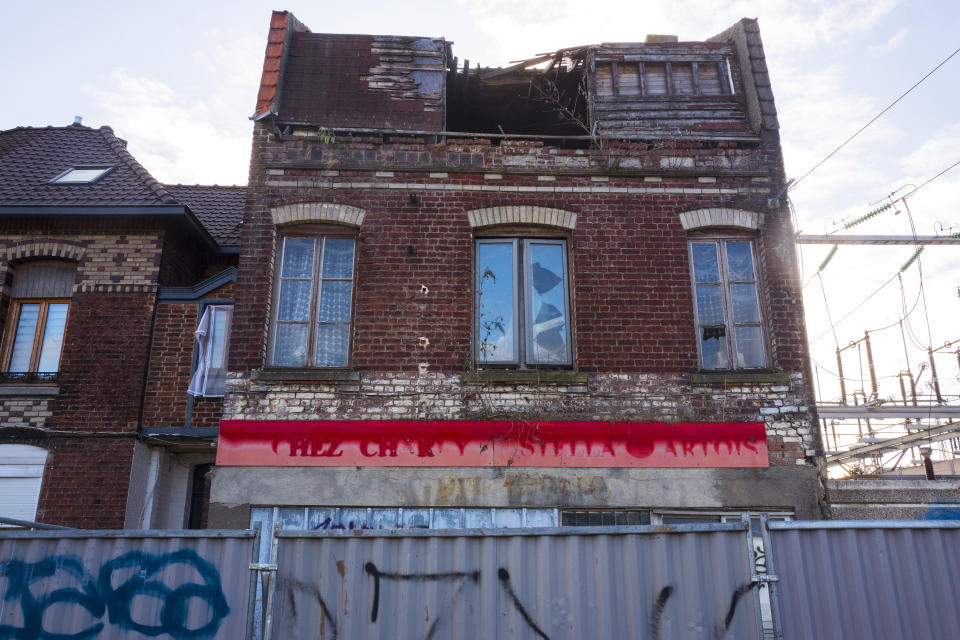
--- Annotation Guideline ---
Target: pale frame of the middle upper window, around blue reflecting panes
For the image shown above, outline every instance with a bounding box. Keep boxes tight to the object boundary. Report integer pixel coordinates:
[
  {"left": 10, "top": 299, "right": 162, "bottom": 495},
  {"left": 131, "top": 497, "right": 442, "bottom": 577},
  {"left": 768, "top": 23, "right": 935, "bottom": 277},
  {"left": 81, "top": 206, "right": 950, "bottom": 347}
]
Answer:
[{"left": 473, "top": 236, "right": 573, "bottom": 367}]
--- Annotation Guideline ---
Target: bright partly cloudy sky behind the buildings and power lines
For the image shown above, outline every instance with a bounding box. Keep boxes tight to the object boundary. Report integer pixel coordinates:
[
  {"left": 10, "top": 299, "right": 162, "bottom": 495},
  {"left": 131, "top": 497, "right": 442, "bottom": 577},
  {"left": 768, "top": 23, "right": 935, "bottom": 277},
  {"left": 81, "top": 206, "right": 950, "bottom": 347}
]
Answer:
[{"left": 0, "top": 0, "right": 960, "bottom": 464}]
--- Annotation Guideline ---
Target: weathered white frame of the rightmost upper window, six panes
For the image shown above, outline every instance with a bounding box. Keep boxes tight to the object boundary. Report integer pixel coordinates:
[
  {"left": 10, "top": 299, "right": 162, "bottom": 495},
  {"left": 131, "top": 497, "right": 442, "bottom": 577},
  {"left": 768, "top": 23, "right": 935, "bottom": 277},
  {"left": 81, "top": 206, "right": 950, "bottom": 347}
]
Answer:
[{"left": 687, "top": 235, "right": 770, "bottom": 371}]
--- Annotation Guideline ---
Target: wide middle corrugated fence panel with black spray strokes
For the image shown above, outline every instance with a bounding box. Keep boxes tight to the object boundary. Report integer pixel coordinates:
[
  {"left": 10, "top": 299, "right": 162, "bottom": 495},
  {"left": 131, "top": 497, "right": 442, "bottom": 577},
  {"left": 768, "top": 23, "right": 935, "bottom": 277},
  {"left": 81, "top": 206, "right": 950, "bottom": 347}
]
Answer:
[{"left": 272, "top": 524, "right": 757, "bottom": 640}]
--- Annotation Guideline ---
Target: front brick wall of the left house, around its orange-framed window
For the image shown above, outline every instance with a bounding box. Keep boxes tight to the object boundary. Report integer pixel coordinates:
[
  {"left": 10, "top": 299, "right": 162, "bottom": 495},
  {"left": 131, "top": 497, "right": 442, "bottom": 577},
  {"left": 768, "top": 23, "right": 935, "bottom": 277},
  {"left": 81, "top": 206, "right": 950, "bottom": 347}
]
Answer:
[{"left": 0, "top": 216, "right": 164, "bottom": 528}]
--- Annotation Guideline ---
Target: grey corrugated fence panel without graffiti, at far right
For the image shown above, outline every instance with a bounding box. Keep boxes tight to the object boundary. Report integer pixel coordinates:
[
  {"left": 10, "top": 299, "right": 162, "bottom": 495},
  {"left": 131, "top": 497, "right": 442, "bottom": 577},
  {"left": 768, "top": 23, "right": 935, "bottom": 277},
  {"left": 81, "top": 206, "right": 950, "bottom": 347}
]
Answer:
[{"left": 767, "top": 521, "right": 960, "bottom": 640}]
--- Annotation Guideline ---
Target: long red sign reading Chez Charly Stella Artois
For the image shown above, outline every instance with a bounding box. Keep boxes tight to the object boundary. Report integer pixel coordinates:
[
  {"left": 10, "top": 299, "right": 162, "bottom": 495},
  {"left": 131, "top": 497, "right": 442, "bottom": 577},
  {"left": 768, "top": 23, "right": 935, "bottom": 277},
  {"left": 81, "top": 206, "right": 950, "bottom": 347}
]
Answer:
[{"left": 217, "top": 420, "right": 769, "bottom": 467}]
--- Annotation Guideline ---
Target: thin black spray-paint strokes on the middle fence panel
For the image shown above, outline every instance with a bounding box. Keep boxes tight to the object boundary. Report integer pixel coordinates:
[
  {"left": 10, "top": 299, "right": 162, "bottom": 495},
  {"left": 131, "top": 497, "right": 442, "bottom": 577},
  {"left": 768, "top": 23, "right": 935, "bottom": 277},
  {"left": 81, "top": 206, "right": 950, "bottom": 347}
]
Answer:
[{"left": 277, "top": 561, "right": 758, "bottom": 640}]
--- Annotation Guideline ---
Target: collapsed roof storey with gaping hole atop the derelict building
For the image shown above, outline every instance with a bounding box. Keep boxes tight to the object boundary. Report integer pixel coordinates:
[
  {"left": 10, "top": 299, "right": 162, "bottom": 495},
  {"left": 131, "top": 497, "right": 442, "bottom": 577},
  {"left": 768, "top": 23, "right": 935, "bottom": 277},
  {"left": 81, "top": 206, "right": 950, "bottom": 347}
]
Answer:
[{"left": 253, "top": 11, "right": 778, "bottom": 140}]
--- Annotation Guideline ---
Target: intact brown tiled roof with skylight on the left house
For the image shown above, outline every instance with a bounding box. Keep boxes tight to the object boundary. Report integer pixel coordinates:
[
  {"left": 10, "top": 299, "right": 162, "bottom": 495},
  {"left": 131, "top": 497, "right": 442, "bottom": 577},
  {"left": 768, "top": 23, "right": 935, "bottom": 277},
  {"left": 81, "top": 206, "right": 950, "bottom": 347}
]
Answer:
[{"left": 0, "top": 124, "right": 246, "bottom": 246}]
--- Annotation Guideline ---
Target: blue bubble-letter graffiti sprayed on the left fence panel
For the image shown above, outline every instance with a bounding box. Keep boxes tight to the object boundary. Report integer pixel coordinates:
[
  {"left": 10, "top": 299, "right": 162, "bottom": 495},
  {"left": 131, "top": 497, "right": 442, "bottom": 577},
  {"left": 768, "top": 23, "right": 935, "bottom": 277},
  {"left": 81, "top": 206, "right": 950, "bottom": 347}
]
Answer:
[{"left": 0, "top": 549, "right": 230, "bottom": 640}]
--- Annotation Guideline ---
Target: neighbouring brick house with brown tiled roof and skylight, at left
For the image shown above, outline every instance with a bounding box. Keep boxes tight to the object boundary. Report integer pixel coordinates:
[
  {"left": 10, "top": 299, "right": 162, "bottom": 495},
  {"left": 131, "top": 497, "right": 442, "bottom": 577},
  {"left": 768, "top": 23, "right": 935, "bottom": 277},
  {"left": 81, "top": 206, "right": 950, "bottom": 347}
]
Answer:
[{"left": 0, "top": 124, "right": 245, "bottom": 528}]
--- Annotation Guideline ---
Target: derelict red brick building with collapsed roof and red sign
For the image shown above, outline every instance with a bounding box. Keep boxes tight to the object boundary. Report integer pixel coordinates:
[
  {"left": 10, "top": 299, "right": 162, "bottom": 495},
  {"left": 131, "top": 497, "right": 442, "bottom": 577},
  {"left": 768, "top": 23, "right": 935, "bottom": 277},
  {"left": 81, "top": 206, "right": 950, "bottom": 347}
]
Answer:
[{"left": 210, "top": 12, "right": 822, "bottom": 528}]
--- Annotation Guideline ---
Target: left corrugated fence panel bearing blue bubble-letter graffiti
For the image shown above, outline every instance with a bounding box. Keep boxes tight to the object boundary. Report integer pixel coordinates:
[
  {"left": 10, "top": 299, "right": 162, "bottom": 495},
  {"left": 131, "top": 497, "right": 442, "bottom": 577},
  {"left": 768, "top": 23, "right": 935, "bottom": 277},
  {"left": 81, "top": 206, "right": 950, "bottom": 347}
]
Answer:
[{"left": 0, "top": 531, "right": 256, "bottom": 640}]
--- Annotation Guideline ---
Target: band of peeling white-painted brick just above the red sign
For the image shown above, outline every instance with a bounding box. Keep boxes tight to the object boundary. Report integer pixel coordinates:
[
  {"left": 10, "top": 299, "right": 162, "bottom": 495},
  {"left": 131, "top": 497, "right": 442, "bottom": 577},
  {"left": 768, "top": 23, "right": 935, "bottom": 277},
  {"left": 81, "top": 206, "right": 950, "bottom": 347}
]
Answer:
[{"left": 223, "top": 372, "right": 817, "bottom": 466}]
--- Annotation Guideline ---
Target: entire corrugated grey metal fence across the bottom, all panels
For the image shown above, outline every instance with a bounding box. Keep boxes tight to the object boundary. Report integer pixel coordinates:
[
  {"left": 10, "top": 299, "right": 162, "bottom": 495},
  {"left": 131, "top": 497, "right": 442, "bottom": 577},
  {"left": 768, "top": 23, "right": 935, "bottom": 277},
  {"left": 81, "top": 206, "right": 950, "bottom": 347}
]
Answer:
[{"left": 0, "top": 521, "right": 960, "bottom": 640}]
